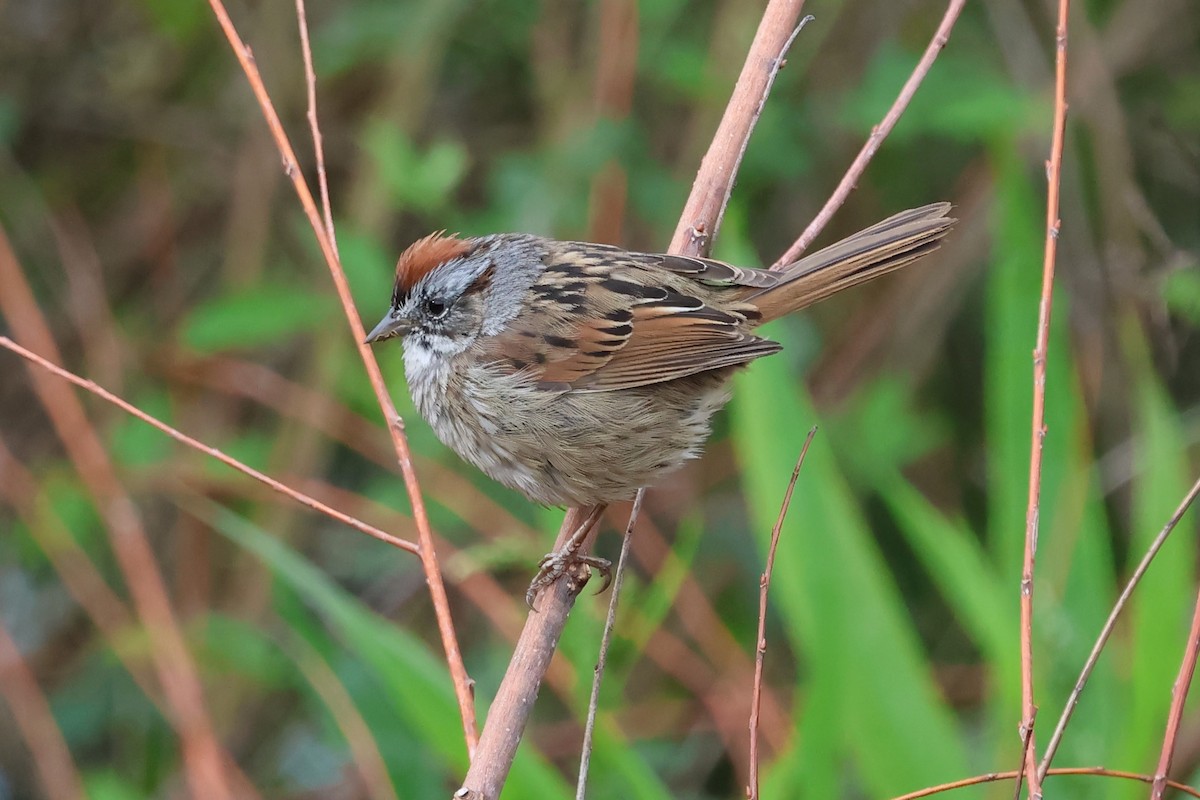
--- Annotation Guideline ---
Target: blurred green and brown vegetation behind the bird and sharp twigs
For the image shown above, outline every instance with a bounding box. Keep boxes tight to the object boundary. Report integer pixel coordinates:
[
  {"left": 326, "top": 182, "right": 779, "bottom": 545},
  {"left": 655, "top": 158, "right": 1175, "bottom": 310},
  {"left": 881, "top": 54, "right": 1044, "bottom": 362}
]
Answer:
[{"left": 0, "top": 0, "right": 1200, "bottom": 800}]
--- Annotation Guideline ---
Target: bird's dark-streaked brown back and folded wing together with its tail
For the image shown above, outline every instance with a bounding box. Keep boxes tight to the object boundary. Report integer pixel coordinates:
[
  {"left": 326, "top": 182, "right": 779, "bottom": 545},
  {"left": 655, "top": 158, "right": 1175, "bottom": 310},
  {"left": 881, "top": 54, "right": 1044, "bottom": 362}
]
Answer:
[{"left": 472, "top": 203, "right": 954, "bottom": 391}]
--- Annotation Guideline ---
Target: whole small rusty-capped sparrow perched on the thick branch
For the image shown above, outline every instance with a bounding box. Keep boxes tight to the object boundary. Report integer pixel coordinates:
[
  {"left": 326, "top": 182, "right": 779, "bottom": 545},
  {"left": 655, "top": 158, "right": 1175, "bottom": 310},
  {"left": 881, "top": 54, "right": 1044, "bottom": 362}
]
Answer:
[{"left": 366, "top": 203, "right": 955, "bottom": 597}]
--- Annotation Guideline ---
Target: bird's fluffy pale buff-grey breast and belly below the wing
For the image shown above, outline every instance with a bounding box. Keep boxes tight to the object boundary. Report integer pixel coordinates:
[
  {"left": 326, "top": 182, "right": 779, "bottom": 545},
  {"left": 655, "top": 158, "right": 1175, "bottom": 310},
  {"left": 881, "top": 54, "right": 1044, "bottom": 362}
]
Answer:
[{"left": 406, "top": 359, "right": 733, "bottom": 505}]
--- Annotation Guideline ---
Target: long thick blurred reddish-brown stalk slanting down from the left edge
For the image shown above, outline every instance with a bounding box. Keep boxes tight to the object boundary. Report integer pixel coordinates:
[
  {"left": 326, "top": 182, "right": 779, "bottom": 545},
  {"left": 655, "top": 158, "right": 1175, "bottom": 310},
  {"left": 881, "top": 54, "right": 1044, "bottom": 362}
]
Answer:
[{"left": 0, "top": 229, "right": 233, "bottom": 800}]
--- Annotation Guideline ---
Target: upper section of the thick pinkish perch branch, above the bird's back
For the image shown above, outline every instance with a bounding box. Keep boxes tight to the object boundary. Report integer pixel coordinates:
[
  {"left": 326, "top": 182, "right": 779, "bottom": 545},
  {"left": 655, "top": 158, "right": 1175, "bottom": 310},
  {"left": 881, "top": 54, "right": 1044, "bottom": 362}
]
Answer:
[{"left": 668, "top": 0, "right": 804, "bottom": 255}]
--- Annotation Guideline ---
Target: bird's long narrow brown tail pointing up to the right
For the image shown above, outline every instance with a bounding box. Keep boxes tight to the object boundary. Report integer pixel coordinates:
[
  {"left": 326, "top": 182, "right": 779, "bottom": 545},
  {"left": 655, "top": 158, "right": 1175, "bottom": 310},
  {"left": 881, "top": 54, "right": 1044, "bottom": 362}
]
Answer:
[{"left": 745, "top": 203, "right": 956, "bottom": 321}]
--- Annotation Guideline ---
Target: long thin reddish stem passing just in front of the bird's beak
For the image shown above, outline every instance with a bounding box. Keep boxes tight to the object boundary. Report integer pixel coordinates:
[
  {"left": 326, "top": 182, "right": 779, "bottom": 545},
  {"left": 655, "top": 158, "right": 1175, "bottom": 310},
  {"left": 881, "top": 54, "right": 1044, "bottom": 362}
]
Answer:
[{"left": 200, "top": 0, "right": 478, "bottom": 754}]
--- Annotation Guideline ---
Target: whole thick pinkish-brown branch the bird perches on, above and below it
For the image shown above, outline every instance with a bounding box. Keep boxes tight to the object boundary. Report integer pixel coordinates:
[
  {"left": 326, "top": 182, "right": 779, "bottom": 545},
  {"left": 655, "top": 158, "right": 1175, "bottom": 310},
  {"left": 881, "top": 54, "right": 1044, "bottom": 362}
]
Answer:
[{"left": 453, "top": 0, "right": 803, "bottom": 800}]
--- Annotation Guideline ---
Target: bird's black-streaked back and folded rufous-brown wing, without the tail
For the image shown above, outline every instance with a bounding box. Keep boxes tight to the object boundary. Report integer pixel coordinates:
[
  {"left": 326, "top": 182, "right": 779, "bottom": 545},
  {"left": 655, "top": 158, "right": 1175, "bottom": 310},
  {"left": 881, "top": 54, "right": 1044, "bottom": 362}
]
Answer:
[{"left": 475, "top": 243, "right": 780, "bottom": 391}]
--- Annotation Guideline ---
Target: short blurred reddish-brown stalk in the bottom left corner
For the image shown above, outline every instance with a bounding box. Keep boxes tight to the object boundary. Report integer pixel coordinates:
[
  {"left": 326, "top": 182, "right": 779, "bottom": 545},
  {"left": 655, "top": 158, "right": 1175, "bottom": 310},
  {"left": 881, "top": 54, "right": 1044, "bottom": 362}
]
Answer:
[{"left": 0, "top": 620, "right": 86, "bottom": 800}]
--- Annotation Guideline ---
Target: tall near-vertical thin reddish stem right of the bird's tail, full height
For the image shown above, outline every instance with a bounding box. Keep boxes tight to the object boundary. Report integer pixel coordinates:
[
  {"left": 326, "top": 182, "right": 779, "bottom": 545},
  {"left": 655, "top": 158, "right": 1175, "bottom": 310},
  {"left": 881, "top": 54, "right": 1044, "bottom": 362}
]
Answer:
[{"left": 1020, "top": 0, "right": 1070, "bottom": 800}]
